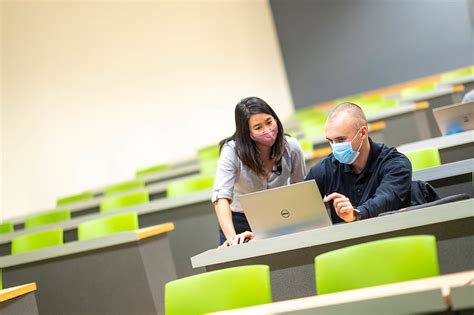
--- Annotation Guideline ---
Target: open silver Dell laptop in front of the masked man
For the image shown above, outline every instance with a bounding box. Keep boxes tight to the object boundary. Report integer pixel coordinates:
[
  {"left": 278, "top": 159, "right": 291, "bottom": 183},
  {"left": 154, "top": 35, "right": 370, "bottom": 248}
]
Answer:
[{"left": 240, "top": 180, "right": 332, "bottom": 239}]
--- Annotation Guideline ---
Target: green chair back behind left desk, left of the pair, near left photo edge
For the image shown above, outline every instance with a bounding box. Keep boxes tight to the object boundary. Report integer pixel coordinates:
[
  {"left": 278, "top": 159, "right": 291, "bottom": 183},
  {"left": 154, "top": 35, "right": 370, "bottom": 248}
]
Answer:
[{"left": 12, "top": 229, "right": 63, "bottom": 255}]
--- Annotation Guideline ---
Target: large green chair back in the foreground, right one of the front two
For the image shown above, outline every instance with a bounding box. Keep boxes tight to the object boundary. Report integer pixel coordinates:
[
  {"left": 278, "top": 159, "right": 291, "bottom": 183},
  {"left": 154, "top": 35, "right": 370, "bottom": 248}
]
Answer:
[{"left": 314, "top": 235, "right": 439, "bottom": 294}]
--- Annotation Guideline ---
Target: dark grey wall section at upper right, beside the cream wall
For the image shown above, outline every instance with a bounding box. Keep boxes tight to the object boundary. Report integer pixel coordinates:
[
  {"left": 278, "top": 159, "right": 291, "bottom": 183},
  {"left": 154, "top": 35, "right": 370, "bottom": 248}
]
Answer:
[{"left": 270, "top": 0, "right": 474, "bottom": 108}]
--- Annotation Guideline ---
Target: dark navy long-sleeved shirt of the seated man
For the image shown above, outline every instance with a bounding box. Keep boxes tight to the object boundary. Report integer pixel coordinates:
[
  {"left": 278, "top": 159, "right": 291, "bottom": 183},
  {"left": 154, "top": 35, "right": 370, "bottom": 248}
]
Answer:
[{"left": 305, "top": 138, "right": 412, "bottom": 223}]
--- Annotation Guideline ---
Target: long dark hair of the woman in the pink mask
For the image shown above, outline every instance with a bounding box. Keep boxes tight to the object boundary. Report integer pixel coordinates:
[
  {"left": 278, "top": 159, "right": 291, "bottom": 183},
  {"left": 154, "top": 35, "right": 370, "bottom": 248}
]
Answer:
[{"left": 219, "top": 97, "right": 286, "bottom": 177}]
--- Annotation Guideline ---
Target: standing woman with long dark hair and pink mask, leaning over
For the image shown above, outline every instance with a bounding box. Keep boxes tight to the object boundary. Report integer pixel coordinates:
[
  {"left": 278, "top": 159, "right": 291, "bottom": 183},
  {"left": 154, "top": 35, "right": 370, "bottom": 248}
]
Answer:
[{"left": 212, "top": 97, "right": 306, "bottom": 247}]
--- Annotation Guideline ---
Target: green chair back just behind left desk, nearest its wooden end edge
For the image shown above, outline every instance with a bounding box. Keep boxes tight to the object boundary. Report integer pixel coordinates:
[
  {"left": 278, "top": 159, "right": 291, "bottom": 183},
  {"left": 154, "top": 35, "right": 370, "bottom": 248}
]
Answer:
[{"left": 77, "top": 212, "right": 138, "bottom": 240}]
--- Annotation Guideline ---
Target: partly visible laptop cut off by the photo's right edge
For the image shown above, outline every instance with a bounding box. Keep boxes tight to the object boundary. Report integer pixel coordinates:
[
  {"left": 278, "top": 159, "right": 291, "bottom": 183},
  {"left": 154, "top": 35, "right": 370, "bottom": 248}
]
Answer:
[{"left": 433, "top": 102, "right": 474, "bottom": 136}]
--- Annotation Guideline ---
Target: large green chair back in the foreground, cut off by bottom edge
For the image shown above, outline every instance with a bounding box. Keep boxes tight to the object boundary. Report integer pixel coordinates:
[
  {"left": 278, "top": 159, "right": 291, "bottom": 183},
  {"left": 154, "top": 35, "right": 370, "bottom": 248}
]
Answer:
[{"left": 165, "top": 265, "right": 272, "bottom": 315}]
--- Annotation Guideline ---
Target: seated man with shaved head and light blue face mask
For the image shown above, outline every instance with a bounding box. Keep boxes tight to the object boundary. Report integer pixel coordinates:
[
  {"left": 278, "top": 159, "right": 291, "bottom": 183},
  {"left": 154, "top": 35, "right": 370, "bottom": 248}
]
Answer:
[{"left": 306, "top": 103, "right": 412, "bottom": 223}]
